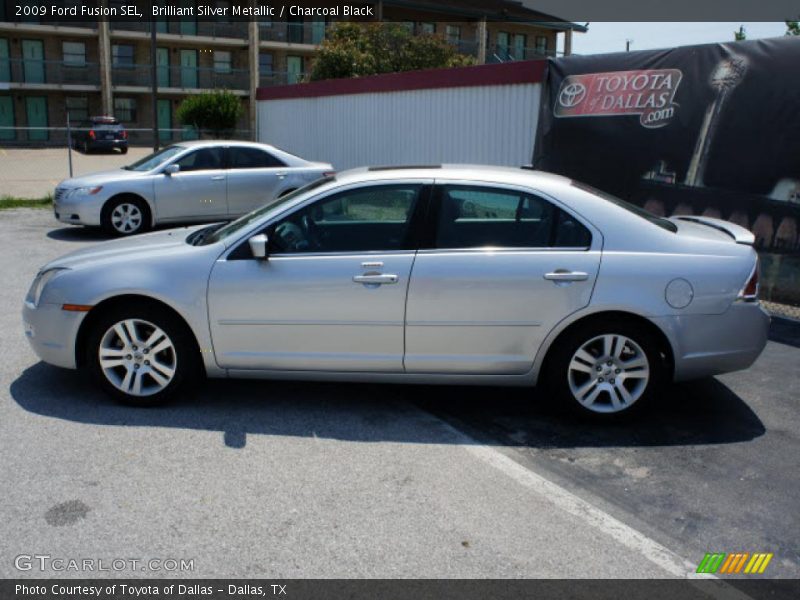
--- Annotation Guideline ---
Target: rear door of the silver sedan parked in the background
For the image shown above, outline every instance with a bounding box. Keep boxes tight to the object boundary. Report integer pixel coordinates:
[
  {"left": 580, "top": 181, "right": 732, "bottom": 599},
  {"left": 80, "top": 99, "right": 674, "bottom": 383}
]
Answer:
[{"left": 228, "top": 146, "right": 288, "bottom": 217}]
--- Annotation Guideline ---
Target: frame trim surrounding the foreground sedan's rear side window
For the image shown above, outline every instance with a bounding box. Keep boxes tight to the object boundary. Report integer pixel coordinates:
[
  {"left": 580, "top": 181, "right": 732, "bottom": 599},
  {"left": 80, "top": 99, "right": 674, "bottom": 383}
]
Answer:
[{"left": 419, "top": 179, "right": 603, "bottom": 254}]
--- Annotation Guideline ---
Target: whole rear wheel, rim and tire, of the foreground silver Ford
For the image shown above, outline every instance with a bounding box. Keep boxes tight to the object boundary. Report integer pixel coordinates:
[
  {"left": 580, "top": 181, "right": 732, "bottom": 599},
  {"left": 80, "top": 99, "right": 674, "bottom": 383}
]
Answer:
[{"left": 545, "top": 320, "right": 665, "bottom": 419}]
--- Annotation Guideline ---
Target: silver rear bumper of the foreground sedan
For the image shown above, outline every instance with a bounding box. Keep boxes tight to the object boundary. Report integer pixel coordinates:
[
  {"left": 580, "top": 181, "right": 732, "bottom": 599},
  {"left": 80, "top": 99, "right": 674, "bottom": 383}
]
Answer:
[{"left": 653, "top": 302, "right": 769, "bottom": 381}]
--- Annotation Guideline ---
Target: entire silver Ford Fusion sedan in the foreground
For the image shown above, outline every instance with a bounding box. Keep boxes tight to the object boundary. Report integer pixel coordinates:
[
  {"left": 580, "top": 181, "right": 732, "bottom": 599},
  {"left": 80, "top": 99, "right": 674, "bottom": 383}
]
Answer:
[{"left": 24, "top": 166, "right": 769, "bottom": 417}]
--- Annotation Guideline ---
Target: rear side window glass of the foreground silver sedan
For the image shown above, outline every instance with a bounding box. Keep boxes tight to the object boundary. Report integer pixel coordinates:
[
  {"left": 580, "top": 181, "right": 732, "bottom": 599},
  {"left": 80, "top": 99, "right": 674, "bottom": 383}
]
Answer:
[{"left": 435, "top": 185, "right": 592, "bottom": 249}]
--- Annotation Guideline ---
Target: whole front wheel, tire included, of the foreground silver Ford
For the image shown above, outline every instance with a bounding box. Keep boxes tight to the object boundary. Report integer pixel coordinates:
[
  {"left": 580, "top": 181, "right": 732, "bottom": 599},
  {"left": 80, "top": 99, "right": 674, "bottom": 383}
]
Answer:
[{"left": 86, "top": 306, "right": 200, "bottom": 406}]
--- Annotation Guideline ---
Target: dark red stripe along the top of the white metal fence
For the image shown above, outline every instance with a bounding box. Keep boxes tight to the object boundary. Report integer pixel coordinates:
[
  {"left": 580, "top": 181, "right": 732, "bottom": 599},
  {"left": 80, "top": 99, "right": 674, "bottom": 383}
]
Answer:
[{"left": 256, "top": 60, "right": 547, "bottom": 100}]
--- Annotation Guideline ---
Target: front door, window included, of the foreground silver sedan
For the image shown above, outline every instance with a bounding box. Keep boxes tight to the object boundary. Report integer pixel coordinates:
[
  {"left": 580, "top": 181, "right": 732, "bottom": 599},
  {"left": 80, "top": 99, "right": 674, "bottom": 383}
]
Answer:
[{"left": 208, "top": 181, "right": 430, "bottom": 373}]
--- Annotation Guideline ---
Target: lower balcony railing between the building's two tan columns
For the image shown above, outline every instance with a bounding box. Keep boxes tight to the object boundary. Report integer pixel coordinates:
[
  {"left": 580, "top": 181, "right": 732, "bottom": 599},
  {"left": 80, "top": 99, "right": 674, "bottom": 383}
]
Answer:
[{"left": 111, "top": 64, "right": 250, "bottom": 90}]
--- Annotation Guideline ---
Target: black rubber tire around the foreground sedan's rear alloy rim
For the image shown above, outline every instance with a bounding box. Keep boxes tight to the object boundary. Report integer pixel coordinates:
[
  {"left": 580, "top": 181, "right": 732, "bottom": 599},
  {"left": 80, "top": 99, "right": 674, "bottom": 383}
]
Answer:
[{"left": 543, "top": 319, "right": 666, "bottom": 421}]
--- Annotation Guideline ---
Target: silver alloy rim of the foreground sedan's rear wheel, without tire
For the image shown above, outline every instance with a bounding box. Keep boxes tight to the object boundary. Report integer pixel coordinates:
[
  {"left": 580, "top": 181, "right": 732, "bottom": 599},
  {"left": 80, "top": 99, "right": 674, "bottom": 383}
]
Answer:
[{"left": 567, "top": 334, "right": 650, "bottom": 413}]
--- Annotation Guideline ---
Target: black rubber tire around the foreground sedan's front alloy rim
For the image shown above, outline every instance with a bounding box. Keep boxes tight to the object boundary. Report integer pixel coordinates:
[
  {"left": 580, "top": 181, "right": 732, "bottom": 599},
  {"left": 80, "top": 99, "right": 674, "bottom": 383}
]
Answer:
[{"left": 85, "top": 304, "right": 203, "bottom": 407}]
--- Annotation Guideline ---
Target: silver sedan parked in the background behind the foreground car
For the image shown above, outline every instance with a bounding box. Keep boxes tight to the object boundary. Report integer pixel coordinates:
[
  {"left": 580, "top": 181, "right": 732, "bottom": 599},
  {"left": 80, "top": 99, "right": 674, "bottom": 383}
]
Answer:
[{"left": 53, "top": 141, "right": 333, "bottom": 236}]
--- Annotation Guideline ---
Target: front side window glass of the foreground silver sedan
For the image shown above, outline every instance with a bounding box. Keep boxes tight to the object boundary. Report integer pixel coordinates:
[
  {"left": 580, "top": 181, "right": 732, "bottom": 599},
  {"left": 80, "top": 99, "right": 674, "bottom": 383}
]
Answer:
[{"left": 269, "top": 184, "right": 422, "bottom": 254}]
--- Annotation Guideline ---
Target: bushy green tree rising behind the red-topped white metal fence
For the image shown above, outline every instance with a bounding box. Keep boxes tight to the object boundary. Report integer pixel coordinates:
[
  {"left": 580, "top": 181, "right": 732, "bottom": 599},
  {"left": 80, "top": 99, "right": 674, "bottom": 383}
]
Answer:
[{"left": 310, "top": 22, "right": 475, "bottom": 81}]
